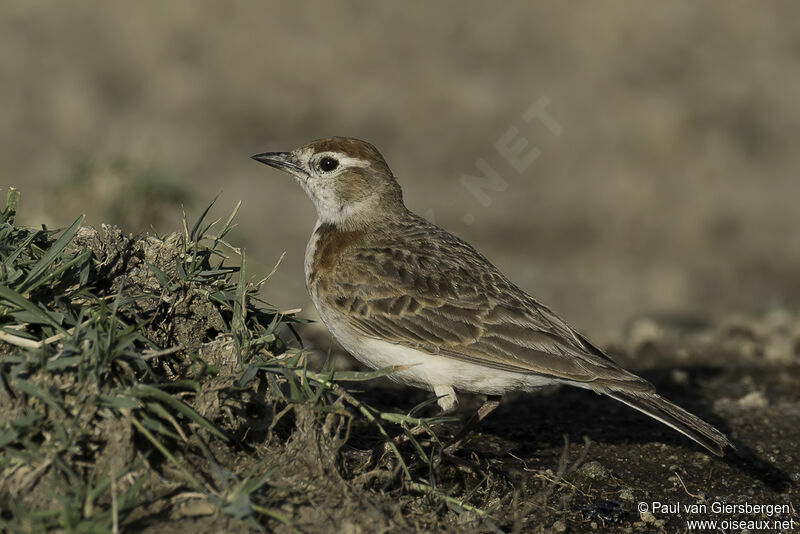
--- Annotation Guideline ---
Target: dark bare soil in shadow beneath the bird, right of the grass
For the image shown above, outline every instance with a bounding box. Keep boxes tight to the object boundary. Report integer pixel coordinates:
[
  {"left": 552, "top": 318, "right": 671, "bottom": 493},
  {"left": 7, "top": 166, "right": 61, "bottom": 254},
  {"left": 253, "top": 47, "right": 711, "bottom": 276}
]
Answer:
[{"left": 238, "top": 312, "right": 800, "bottom": 533}]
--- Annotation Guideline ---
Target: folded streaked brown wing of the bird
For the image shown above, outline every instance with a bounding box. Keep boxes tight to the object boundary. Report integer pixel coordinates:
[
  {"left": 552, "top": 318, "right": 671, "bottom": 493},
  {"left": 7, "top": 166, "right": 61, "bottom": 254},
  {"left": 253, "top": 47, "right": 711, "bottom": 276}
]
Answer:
[{"left": 320, "top": 223, "right": 653, "bottom": 391}]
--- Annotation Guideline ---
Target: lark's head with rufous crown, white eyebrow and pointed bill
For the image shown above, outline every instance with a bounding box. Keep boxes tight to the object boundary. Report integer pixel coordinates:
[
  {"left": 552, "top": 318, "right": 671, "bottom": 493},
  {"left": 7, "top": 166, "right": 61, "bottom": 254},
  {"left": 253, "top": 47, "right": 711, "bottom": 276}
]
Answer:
[{"left": 253, "top": 137, "right": 405, "bottom": 228}]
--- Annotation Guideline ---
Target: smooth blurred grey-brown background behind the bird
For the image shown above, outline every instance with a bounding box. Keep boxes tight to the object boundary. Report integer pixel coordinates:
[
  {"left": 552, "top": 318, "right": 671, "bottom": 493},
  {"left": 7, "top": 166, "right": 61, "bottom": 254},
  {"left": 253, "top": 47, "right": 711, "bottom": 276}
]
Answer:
[{"left": 0, "top": 0, "right": 800, "bottom": 343}]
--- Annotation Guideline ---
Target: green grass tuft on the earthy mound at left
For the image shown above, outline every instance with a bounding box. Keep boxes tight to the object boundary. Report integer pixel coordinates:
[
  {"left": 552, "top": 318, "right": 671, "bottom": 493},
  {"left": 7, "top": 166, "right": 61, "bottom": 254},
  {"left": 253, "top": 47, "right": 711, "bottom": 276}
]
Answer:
[{"left": 0, "top": 189, "right": 486, "bottom": 532}]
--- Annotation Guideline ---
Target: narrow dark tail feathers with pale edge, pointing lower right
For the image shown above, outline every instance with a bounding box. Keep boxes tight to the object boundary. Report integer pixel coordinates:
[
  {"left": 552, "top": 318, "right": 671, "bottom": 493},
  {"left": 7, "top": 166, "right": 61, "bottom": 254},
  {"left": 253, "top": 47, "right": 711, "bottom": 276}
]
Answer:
[{"left": 603, "top": 389, "right": 733, "bottom": 456}]
